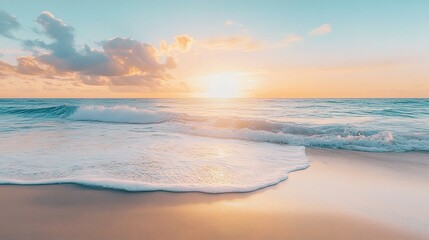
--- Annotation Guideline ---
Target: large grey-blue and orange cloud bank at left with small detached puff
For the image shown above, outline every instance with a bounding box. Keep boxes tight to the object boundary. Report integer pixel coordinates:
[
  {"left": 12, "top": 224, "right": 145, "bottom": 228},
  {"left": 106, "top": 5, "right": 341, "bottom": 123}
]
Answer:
[{"left": 0, "top": 11, "right": 193, "bottom": 87}]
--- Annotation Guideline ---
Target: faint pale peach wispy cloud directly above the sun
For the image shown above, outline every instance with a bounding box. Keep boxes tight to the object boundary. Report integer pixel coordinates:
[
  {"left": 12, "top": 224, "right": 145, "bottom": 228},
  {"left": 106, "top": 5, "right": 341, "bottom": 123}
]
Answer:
[{"left": 202, "top": 35, "right": 263, "bottom": 52}]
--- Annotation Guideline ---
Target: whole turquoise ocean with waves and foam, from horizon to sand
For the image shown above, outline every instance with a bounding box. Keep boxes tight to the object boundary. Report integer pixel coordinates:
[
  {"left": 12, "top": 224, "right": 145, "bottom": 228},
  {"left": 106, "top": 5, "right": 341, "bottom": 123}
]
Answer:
[{"left": 0, "top": 99, "right": 429, "bottom": 193}]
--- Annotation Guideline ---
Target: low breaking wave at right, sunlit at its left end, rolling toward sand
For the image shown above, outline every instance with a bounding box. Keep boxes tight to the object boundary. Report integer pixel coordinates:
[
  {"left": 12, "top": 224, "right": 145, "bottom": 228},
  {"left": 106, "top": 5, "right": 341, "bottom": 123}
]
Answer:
[{"left": 166, "top": 118, "right": 429, "bottom": 152}]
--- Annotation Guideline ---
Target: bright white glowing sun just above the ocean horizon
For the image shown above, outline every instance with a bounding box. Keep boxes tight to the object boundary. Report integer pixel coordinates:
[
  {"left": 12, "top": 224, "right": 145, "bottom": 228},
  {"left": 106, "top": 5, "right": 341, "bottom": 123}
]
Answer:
[{"left": 204, "top": 73, "right": 242, "bottom": 98}]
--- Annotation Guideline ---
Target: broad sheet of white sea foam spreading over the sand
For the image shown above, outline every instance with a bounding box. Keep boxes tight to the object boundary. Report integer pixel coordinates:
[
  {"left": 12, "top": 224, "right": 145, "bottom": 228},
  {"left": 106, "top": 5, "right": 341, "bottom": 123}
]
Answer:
[{"left": 0, "top": 129, "right": 308, "bottom": 193}]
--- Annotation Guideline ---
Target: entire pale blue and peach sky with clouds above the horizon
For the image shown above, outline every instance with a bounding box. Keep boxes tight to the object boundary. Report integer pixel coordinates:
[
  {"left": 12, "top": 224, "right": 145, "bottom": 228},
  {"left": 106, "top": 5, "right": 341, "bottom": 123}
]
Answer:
[{"left": 0, "top": 0, "right": 429, "bottom": 98}]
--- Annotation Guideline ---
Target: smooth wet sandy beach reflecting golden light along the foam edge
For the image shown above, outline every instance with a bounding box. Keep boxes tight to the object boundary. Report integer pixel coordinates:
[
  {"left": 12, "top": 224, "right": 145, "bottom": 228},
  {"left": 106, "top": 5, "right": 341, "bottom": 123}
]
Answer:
[{"left": 0, "top": 149, "right": 429, "bottom": 240}]
